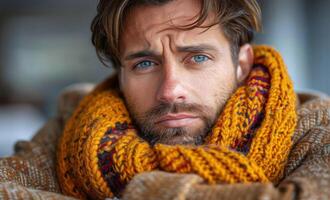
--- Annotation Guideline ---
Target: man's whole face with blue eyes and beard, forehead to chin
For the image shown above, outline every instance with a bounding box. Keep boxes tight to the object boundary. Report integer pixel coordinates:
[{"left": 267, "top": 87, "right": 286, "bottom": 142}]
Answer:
[{"left": 120, "top": 0, "right": 237, "bottom": 145}]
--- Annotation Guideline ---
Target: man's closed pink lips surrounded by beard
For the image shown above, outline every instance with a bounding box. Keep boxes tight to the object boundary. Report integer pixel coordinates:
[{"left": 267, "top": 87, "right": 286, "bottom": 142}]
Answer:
[{"left": 155, "top": 114, "right": 198, "bottom": 128}]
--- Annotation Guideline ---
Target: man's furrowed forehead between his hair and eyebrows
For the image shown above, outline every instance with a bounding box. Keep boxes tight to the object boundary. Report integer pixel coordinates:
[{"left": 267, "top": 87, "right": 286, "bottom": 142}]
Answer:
[{"left": 120, "top": 0, "right": 223, "bottom": 54}]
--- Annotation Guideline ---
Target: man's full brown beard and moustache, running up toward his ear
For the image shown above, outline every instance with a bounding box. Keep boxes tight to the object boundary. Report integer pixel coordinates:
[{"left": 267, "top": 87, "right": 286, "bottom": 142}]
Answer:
[{"left": 124, "top": 78, "right": 238, "bottom": 145}]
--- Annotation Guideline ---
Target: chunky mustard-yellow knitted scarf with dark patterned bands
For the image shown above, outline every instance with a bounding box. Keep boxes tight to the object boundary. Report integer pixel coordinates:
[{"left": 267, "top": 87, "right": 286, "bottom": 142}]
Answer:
[{"left": 57, "top": 46, "right": 297, "bottom": 199}]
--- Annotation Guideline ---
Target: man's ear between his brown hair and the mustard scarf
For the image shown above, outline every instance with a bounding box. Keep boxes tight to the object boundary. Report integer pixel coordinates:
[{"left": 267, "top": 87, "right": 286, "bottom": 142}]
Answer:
[{"left": 236, "top": 44, "right": 254, "bottom": 84}]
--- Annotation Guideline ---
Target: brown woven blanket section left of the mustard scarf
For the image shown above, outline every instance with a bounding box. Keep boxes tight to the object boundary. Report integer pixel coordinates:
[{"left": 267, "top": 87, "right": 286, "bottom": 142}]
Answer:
[{"left": 0, "top": 84, "right": 93, "bottom": 199}]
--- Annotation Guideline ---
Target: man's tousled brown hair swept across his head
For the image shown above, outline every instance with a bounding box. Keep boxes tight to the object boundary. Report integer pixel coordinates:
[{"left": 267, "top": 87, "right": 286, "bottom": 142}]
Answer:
[{"left": 91, "top": 0, "right": 261, "bottom": 67}]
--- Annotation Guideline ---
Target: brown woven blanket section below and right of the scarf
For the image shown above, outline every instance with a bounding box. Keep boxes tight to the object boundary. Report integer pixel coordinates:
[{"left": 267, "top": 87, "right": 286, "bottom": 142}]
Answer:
[{"left": 123, "top": 98, "right": 330, "bottom": 200}]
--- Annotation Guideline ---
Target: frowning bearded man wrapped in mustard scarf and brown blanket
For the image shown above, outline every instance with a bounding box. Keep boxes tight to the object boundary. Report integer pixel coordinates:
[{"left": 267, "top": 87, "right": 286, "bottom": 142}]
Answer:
[{"left": 2, "top": 0, "right": 330, "bottom": 199}]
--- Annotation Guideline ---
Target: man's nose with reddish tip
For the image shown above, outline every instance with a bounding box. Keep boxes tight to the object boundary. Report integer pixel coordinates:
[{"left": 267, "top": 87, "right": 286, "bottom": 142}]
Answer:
[{"left": 157, "top": 63, "right": 187, "bottom": 103}]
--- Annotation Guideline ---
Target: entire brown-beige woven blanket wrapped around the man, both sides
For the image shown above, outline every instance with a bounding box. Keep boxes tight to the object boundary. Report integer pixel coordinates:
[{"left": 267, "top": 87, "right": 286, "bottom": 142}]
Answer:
[{"left": 0, "top": 85, "right": 330, "bottom": 200}]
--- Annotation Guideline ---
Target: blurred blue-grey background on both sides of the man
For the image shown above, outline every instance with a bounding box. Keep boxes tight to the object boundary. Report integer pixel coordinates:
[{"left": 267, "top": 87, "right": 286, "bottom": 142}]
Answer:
[{"left": 0, "top": 0, "right": 330, "bottom": 157}]
